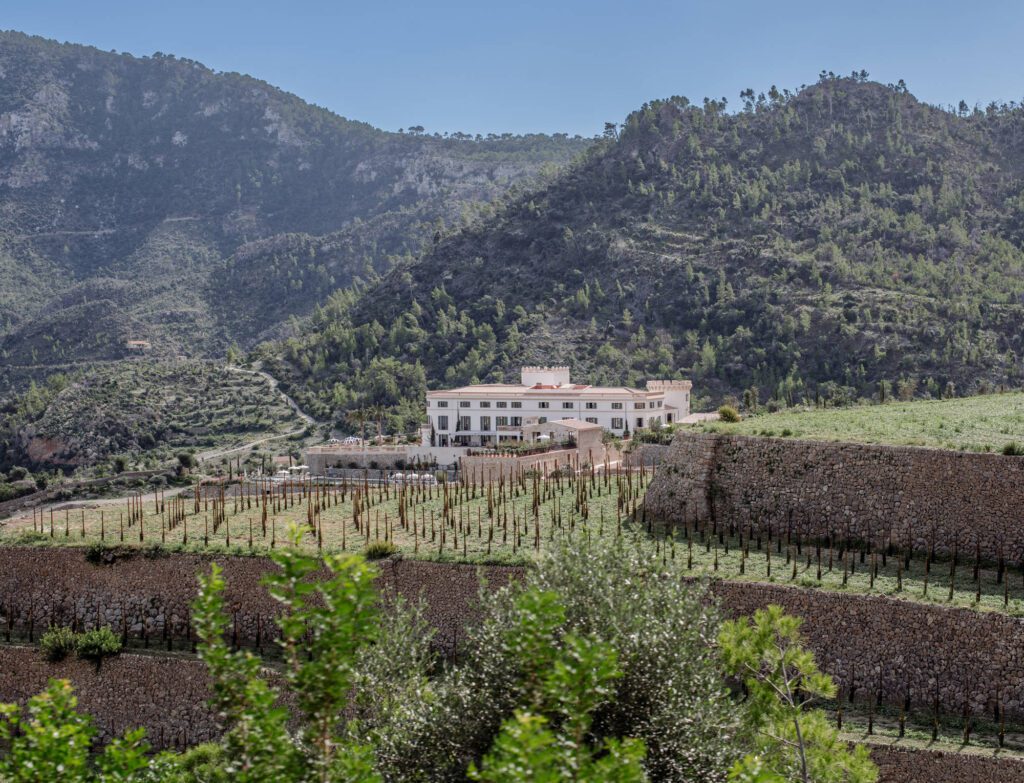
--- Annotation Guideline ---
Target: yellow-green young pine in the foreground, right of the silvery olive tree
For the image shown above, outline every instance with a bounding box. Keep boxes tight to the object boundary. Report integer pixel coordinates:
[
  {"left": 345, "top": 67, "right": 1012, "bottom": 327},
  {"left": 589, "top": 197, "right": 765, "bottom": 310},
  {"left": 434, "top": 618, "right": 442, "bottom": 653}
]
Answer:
[{"left": 719, "top": 605, "right": 878, "bottom": 783}]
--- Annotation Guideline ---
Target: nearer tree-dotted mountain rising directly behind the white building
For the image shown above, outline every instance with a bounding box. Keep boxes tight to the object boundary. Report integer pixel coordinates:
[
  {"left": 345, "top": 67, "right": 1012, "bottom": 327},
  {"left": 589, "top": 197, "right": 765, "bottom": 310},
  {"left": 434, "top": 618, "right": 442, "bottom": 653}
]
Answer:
[{"left": 256, "top": 73, "right": 1024, "bottom": 428}]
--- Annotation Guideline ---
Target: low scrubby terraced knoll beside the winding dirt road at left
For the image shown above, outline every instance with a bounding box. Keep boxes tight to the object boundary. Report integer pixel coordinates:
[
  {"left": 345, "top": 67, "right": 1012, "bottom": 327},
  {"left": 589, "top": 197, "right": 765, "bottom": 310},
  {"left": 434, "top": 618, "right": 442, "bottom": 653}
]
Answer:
[{"left": 0, "top": 361, "right": 304, "bottom": 470}]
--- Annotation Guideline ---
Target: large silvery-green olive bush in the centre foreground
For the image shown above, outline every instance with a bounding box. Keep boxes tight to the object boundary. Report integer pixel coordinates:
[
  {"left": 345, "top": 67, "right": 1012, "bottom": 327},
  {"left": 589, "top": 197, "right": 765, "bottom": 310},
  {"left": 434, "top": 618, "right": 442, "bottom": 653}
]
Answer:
[{"left": 387, "top": 541, "right": 738, "bottom": 783}]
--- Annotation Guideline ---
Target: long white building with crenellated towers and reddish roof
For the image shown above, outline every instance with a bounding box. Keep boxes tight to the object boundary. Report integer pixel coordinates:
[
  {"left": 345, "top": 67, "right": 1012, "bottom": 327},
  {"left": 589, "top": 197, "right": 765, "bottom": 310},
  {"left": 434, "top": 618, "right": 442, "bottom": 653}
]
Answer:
[{"left": 423, "top": 367, "right": 692, "bottom": 447}]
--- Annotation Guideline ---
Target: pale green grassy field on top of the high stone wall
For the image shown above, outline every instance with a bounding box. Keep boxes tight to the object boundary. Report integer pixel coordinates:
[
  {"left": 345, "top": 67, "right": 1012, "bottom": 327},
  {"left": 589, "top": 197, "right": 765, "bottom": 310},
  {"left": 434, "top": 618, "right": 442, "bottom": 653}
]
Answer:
[{"left": 701, "top": 392, "right": 1024, "bottom": 452}]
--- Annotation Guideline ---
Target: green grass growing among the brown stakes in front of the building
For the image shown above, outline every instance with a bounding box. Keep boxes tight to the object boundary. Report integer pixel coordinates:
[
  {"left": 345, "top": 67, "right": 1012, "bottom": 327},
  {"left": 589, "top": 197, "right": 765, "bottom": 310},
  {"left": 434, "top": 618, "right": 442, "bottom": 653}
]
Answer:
[{"left": 0, "top": 474, "right": 649, "bottom": 564}]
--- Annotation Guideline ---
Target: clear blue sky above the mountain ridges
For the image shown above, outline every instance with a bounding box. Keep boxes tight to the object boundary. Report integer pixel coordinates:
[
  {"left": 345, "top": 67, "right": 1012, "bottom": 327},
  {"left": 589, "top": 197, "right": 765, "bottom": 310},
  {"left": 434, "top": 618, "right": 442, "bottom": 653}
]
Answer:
[{"left": 8, "top": 0, "right": 1024, "bottom": 135}]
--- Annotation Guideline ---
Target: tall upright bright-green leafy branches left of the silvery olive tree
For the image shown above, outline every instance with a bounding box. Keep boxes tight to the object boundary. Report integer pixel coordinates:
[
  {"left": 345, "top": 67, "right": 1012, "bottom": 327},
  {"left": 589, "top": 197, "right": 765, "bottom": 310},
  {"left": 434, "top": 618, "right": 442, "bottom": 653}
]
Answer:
[{"left": 194, "top": 533, "right": 379, "bottom": 783}]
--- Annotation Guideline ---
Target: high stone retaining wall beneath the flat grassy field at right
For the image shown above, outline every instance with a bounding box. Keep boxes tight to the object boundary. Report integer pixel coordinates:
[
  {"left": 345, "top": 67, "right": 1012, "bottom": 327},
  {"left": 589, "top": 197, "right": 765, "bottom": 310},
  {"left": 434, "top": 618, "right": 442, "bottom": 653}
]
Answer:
[{"left": 645, "top": 433, "right": 1024, "bottom": 563}]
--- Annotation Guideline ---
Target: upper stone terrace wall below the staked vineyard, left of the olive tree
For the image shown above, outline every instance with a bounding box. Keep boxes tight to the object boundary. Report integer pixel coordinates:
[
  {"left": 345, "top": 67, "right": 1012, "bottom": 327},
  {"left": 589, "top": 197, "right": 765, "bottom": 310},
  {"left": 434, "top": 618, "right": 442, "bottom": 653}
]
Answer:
[{"left": 0, "top": 547, "right": 520, "bottom": 650}]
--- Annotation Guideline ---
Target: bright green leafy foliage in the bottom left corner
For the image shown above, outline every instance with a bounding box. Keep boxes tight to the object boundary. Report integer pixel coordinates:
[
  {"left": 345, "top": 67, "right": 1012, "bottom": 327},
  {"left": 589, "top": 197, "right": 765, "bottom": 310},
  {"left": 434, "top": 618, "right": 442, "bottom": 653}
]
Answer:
[{"left": 0, "top": 680, "right": 153, "bottom": 783}]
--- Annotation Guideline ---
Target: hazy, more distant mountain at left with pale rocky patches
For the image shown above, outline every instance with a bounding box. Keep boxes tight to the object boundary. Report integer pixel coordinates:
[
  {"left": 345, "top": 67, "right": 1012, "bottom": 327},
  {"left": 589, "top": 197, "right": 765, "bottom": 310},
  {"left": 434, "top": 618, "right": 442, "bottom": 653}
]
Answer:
[{"left": 0, "top": 32, "right": 590, "bottom": 390}]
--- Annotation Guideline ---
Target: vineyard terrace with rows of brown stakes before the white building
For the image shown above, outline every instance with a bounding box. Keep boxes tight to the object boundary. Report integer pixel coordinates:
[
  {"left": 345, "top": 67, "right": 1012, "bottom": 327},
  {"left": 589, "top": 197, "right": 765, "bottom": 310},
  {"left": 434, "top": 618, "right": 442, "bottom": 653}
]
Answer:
[{"left": 0, "top": 468, "right": 651, "bottom": 562}]
